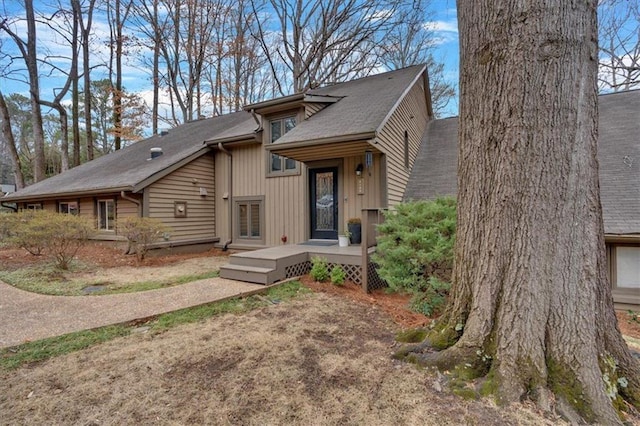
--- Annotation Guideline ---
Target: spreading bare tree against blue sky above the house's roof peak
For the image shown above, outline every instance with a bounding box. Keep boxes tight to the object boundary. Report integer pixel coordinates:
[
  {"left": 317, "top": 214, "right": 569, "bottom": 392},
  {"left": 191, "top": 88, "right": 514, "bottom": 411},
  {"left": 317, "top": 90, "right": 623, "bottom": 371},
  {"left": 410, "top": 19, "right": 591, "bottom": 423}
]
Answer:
[{"left": 252, "top": 0, "right": 401, "bottom": 95}]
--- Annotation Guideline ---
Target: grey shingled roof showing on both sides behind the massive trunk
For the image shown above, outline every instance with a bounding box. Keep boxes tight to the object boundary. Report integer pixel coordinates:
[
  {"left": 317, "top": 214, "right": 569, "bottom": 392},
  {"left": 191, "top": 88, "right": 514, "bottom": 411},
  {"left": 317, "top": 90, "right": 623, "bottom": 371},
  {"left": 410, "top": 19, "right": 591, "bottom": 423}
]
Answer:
[{"left": 404, "top": 90, "right": 640, "bottom": 235}]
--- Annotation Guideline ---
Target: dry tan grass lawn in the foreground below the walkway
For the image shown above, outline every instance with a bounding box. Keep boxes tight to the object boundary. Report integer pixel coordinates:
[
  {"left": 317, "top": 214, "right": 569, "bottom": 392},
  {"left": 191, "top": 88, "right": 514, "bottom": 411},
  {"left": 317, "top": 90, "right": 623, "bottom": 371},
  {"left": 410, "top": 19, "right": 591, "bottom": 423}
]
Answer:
[{"left": 0, "top": 294, "right": 558, "bottom": 425}]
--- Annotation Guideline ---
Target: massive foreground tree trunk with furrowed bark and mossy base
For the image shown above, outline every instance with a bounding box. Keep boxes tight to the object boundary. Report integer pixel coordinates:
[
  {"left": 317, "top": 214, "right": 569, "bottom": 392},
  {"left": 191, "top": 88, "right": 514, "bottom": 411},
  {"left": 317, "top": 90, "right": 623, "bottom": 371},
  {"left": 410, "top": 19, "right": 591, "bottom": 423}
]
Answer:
[{"left": 404, "top": 0, "right": 640, "bottom": 424}]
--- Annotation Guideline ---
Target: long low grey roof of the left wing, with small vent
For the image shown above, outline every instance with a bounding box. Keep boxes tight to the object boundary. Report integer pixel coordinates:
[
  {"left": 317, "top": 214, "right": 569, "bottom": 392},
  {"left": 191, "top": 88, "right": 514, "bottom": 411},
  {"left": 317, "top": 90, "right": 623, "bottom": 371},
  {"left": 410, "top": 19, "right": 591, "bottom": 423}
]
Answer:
[{"left": 2, "top": 111, "right": 256, "bottom": 202}]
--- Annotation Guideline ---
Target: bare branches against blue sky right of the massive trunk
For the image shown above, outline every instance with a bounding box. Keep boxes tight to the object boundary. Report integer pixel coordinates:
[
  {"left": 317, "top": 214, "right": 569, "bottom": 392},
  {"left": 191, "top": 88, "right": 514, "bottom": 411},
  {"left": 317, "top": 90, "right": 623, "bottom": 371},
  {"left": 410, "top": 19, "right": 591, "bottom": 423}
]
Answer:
[{"left": 598, "top": 0, "right": 640, "bottom": 92}]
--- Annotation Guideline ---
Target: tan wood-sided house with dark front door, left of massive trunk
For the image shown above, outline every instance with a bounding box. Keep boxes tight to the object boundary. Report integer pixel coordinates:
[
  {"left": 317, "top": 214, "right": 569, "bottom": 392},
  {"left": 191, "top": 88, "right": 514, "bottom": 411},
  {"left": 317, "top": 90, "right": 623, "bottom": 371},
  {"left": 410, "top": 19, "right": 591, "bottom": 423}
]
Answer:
[{"left": 0, "top": 66, "right": 432, "bottom": 249}]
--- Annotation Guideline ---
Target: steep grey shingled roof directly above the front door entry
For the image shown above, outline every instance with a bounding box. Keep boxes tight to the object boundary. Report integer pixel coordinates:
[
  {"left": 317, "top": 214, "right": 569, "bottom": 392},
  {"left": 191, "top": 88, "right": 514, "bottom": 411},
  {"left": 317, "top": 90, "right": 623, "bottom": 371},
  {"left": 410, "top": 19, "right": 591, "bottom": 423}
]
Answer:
[{"left": 274, "top": 65, "right": 425, "bottom": 145}]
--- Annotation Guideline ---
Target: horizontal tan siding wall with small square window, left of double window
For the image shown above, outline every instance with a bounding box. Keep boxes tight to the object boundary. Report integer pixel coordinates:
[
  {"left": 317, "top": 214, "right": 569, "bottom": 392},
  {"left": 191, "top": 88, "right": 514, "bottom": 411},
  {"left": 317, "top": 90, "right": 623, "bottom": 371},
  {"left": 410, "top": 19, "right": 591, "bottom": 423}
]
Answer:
[{"left": 146, "top": 153, "right": 216, "bottom": 241}]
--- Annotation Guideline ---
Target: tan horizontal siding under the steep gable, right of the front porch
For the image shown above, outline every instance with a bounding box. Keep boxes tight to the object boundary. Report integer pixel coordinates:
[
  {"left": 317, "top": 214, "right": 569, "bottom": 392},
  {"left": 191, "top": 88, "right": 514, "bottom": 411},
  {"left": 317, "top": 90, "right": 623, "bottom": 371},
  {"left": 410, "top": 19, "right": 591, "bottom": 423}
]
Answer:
[{"left": 378, "top": 79, "right": 429, "bottom": 207}]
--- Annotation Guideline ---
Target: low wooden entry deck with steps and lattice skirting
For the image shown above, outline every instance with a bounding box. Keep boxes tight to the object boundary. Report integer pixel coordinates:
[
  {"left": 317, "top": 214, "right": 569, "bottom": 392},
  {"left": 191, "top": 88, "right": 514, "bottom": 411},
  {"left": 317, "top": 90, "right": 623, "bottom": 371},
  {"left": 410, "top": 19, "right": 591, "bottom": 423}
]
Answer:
[{"left": 220, "top": 242, "right": 363, "bottom": 284}]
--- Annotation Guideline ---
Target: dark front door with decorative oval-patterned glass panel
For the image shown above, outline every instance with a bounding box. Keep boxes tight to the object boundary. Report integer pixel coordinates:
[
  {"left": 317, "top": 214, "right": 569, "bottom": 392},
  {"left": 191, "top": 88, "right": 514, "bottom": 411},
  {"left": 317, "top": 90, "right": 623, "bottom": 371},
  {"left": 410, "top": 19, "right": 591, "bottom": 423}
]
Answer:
[{"left": 309, "top": 167, "right": 338, "bottom": 240}]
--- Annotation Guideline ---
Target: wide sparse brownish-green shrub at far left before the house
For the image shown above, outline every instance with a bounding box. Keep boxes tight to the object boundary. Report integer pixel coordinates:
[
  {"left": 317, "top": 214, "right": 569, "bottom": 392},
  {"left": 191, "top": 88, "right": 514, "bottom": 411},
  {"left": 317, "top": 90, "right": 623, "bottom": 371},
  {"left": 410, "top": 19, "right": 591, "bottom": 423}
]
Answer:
[{"left": 3, "top": 210, "right": 95, "bottom": 269}]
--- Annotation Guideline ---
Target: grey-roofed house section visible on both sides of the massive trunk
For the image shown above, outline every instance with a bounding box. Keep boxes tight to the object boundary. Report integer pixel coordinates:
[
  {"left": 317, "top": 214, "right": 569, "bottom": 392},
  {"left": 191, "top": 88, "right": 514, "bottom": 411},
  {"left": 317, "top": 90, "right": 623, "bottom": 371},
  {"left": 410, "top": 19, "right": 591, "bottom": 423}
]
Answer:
[{"left": 404, "top": 90, "right": 640, "bottom": 306}]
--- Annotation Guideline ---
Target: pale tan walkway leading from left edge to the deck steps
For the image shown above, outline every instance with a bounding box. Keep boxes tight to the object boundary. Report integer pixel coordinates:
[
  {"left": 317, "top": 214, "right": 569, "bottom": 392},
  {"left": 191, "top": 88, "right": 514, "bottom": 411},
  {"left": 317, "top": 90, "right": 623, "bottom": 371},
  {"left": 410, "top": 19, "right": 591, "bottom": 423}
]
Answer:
[{"left": 0, "top": 278, "right": 265, "bottom": 348}]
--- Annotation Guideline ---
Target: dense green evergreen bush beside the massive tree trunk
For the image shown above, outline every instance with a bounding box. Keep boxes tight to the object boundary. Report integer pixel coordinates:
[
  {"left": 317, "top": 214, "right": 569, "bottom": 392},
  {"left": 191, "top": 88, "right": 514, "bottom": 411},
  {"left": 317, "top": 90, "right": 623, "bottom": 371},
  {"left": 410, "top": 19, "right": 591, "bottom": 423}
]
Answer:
[{"left": 372, "top": 198, "right": 456, "bottom": 315}]
